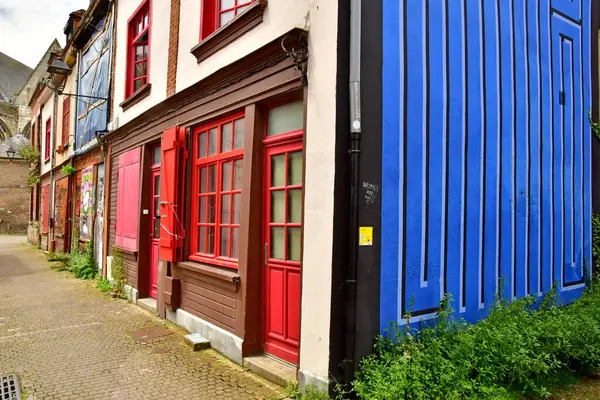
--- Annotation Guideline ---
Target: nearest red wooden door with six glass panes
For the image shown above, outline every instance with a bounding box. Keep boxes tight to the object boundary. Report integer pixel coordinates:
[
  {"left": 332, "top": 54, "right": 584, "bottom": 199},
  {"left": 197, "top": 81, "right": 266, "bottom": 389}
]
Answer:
[{"left": 263, "top": 142, "right": 303, "bottom": 364}]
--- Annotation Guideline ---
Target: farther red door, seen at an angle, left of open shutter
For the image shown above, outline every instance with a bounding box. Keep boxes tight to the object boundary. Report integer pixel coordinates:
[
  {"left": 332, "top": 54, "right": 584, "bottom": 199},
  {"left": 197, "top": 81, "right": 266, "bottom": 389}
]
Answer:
[{"left": 148, "top": 146, "right": 161, "bottom": 298}]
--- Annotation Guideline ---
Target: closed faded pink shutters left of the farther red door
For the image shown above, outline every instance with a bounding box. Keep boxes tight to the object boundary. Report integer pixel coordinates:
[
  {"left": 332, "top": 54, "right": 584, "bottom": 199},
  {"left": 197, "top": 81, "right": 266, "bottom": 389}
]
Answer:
[{"left": 115, "top": 147, "right": 140, "bottom": 251}]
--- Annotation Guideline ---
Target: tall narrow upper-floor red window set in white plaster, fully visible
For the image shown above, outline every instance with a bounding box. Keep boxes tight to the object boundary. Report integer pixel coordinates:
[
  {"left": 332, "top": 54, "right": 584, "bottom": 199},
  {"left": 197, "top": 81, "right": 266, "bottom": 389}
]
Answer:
[{"left": 125, "top": 0, "right": 150, "bottom": 98}]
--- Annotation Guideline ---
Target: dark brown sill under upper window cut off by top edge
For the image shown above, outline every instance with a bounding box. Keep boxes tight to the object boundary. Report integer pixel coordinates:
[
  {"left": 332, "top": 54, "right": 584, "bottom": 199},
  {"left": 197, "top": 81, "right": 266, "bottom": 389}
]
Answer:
[{"left": 190, "top": 0, "right": 267, "bottom": 63}]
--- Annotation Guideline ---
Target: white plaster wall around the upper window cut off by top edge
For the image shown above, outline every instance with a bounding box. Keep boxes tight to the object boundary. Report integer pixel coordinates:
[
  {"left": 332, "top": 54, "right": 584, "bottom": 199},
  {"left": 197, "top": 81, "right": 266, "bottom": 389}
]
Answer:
[{"left": 177, "top": 0, "right": 310, "bottom": 92}]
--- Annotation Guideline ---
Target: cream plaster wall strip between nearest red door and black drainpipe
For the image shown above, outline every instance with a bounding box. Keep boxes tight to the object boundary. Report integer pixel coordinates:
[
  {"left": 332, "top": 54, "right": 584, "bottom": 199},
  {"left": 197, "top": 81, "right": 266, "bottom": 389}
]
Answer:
[{"left": 300, "top": 0, "right": 338, "bottom": 384}]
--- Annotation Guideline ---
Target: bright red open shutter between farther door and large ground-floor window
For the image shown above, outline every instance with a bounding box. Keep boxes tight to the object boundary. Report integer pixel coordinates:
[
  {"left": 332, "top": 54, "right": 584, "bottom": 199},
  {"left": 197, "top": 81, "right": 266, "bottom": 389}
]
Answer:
[{"left": 159, "top": 127, "right": 186, "bottom": 261}]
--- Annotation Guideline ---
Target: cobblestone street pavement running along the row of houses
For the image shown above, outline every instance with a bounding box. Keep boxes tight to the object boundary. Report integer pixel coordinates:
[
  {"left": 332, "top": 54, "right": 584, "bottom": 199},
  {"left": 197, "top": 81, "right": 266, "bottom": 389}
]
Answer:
[{"left": 0, "top": 236, "right": 284, "bottom": 400}]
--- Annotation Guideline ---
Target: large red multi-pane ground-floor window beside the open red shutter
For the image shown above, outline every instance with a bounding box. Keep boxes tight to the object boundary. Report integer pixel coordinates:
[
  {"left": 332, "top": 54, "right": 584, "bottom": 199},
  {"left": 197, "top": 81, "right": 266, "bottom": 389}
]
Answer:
[{"left": 190, "top": 114, "right": 244, "bottom": 268}]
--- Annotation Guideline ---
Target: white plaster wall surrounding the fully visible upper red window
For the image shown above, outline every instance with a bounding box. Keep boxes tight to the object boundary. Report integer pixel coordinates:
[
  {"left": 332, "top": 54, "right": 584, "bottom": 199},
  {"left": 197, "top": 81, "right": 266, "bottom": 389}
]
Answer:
[{"left": 113, "top": 0, "right": 171, "bottom": 126}]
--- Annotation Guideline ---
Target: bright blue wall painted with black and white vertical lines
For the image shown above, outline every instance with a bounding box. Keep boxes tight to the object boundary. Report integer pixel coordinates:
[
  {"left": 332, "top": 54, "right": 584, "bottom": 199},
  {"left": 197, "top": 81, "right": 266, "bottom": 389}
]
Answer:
[{"left": 380, "top": 0, "right": 591, "bottom": 330}]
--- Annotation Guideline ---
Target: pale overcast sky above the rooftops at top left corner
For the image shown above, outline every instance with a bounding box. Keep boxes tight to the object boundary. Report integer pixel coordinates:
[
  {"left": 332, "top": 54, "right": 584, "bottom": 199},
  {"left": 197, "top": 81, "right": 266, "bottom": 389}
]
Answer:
[{"left": 0, "top": 0, "right": 90, "bottom": 68}]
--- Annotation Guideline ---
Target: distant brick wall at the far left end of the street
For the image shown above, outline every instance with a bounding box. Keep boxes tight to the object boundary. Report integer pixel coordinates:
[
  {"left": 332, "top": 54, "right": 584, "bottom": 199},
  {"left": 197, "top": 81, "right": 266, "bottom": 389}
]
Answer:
[{"left": 0, "top": 159, "right": 29, "bottom": 234}]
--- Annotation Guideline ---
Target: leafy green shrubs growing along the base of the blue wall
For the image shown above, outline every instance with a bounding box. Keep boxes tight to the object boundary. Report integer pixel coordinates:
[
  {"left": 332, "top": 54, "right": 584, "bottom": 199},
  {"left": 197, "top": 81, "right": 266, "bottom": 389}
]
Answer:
[{"left": 353, "top": 283, "right": 600, "bottom": 400}]
